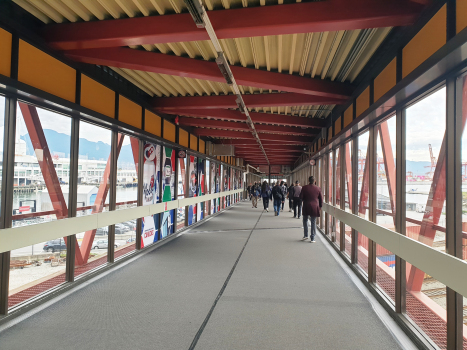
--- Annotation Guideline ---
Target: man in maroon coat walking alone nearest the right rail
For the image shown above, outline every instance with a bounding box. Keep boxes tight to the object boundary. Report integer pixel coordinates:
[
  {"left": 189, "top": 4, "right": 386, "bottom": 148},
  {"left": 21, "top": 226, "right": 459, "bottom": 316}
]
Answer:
[{"left": 300, "top": 176, "right": 323, "bottom": 243}]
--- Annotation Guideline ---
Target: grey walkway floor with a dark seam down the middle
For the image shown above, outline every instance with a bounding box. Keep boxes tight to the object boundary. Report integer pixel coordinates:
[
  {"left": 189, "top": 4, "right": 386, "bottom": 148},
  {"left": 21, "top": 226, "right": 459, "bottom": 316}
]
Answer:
[{"left": 0, "top": 202, "right": 400, "bottom": 350}]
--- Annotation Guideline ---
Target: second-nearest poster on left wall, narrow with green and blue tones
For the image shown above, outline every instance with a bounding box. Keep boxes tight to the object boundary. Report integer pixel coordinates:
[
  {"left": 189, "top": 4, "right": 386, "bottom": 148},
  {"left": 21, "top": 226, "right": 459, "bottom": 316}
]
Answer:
[{"left": 161, "top": 147, "right": 175, "bottom": 238}]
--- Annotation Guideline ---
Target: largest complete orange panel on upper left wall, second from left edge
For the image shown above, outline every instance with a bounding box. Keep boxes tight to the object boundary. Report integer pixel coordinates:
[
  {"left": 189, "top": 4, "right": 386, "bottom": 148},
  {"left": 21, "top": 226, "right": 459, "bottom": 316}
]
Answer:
[{"left": 18, "top": 40, "right": 76, "bottom": 102}]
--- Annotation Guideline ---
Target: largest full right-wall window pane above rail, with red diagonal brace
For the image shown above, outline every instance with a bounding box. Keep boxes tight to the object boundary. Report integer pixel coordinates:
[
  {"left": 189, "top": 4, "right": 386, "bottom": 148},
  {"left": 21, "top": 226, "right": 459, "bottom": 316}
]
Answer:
[{"left": 405, "top": 87, "right": 446, "bottom": 249}]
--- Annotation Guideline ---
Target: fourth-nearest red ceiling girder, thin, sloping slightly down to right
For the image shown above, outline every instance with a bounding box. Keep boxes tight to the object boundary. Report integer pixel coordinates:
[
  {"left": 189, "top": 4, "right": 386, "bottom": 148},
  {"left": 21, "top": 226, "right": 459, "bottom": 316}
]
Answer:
[{"left": 168, "top": 109, "right": 326, "bottom": 128}]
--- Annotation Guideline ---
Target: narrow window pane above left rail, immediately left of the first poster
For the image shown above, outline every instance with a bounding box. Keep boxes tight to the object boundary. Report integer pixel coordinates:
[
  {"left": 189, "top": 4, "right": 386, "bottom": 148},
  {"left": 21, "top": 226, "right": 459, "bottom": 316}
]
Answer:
[{"left": 116, "top": 133, "right": 139, "bottom": 210}]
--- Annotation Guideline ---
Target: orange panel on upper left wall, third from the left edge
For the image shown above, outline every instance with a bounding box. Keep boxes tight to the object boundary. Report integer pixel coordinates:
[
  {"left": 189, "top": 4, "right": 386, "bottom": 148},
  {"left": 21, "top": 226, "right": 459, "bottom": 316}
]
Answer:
[{"left": 81, "top": 74, "right": 115, "bottom": 118}]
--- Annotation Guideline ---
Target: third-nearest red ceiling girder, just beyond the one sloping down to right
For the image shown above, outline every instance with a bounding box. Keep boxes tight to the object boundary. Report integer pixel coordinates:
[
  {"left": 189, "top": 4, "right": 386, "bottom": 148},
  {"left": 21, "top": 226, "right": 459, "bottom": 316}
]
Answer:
[{"left": 152, "top": 92, "right": 346, "bottom": 110}]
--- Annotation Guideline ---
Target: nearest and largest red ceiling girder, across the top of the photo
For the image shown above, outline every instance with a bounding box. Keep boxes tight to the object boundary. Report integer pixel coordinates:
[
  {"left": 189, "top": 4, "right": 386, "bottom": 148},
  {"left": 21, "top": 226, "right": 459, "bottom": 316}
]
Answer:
[{"left": 44, "top": 0, "right": 422, "bottom": 50}]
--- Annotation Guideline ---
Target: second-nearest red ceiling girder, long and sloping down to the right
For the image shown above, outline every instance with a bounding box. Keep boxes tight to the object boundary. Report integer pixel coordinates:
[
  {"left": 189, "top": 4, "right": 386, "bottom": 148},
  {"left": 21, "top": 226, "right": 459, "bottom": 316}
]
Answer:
[{"left": 66, "top": 47, "right": 353, "bottom": 99}]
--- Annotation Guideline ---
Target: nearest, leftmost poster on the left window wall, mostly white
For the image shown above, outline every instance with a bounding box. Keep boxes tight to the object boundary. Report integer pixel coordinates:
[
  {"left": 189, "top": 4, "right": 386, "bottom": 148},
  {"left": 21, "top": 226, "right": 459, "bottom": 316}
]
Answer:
[{"left": 141, "top": 142, "right": 161, "bottom": 248}]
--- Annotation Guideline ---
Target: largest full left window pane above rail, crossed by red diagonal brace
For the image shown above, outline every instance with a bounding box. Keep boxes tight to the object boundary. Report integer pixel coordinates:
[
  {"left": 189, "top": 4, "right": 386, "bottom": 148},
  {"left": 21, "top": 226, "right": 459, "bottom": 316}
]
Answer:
[{"left": 13, "top": 102, "right": 71, "bottom": 227}]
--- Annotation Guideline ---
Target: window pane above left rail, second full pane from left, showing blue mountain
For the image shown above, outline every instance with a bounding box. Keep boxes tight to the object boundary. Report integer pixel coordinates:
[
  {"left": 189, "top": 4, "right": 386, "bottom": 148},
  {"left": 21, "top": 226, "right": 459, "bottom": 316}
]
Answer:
[{"left": 77, "top": 121, "right": 112, "bottom": 216}]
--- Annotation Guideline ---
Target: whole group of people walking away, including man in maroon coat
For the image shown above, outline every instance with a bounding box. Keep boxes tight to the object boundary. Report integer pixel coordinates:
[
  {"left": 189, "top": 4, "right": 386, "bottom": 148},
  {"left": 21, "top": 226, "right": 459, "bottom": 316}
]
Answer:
[{"left": 247, "top": 176, "right": 323, "bottom": 243}]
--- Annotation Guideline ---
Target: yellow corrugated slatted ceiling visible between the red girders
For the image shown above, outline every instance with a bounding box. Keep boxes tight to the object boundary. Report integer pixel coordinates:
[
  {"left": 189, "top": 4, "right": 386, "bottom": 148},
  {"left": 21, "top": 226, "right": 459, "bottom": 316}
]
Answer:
[{"left": 13, "top": 0, "right": 391, "bottom": 118}]
